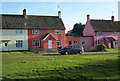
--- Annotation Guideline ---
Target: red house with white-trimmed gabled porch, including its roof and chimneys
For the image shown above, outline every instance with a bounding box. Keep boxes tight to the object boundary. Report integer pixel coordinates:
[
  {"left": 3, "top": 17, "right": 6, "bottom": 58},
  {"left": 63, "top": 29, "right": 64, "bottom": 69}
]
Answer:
[{"left": 23, "top": 9, "right": 65, "bottom": 49}]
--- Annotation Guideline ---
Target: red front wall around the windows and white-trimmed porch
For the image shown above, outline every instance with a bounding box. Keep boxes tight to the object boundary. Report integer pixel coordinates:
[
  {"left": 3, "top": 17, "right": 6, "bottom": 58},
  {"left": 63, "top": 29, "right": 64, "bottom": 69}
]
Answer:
[{"left": 28, "top": 29, "right": 65, "bottom": 48}]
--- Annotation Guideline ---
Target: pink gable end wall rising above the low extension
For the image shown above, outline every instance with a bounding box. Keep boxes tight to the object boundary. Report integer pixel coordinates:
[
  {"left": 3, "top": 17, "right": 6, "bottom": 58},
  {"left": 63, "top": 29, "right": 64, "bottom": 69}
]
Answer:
[{"left": 83, "top": 22, "right": 95, "bottom": 36}]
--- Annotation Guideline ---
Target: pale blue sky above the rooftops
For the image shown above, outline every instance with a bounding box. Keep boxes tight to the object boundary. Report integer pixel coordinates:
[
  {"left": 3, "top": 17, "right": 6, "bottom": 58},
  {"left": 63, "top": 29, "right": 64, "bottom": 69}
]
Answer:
[{"left": 2, "top": 2, "right": 118, "bottom": 32}]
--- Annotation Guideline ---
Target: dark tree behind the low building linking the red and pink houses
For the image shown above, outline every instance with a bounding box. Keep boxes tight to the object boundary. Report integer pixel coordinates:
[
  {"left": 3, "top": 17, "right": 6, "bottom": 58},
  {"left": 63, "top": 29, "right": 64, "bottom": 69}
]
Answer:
[{"left": 66, "top": 23, "right": 85, "bottom": 36}]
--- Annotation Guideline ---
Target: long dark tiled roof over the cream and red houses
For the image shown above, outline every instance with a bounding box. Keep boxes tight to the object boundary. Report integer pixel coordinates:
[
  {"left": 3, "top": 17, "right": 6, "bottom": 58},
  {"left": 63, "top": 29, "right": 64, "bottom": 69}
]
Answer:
[{"left": 2, "top": 14, "right": 65, "bottom": 29}]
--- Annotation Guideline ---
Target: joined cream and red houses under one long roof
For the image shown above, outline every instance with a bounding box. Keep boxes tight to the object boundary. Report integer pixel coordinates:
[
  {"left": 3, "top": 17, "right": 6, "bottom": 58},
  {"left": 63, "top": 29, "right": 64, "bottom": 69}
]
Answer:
[{"left": 0, "top": 9, "right": 65, "bottom": 51}]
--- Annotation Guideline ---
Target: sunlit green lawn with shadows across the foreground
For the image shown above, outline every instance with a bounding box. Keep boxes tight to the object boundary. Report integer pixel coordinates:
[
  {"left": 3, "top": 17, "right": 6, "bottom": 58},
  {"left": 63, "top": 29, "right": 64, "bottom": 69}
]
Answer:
[{"left": 2, "top": 50, "right": 120, "bottom": 81}]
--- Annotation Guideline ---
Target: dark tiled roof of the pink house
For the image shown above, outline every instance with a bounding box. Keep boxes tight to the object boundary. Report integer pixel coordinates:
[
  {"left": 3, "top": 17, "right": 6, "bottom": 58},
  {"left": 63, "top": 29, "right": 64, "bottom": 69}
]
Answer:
[{"left": 90, "top": 20, "right": 120, "bottom": 31}]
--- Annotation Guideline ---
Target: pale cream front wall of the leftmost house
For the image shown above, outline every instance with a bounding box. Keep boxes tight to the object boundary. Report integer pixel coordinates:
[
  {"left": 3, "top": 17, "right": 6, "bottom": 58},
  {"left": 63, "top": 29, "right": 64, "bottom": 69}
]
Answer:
[{"left": 2, "top": 29, "right": 28, "bottom": 51}]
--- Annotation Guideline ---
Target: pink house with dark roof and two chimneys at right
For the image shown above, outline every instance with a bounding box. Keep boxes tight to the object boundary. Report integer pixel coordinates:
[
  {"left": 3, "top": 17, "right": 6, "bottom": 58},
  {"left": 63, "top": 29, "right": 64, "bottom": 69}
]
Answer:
[{"left": 83, "top": 15, "right": 120, "bottom": 48}]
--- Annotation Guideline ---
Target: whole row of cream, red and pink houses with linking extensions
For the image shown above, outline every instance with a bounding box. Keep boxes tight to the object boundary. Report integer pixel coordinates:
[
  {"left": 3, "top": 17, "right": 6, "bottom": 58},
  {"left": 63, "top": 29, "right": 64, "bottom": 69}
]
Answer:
[{"left": 0, "top": 9, "right": 120, "bottom": 51}]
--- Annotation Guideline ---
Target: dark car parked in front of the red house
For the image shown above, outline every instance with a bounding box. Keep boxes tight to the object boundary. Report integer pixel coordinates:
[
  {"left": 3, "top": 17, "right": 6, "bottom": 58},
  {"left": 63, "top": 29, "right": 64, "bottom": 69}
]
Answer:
[{"left": 59, "top": 45, "right": 84, "bottom": 55}]
